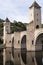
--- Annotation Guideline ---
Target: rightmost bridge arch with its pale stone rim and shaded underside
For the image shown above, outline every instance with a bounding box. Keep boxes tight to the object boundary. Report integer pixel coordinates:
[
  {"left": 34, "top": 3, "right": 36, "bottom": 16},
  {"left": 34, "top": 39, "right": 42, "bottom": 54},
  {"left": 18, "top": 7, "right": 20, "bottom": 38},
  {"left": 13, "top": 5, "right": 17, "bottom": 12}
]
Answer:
[{"left": 34, "top": 28, "right": 43, "bottom": 51}]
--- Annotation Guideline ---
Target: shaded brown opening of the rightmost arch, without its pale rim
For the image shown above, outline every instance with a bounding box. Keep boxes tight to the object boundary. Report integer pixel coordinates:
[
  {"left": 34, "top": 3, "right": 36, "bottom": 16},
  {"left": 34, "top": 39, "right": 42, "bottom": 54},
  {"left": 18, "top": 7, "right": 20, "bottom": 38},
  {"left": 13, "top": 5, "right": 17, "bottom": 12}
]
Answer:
[{"left": 35, "top": 33, "right": 43, "bottom": 50}]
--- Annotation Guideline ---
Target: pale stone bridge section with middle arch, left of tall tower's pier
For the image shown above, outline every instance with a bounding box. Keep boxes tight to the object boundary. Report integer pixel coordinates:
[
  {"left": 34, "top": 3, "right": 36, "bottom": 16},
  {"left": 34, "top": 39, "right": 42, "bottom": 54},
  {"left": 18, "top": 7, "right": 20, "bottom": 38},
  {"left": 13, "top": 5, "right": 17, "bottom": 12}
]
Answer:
[{"left": 12, "top": 31, "right": 26, "bottom": 48}]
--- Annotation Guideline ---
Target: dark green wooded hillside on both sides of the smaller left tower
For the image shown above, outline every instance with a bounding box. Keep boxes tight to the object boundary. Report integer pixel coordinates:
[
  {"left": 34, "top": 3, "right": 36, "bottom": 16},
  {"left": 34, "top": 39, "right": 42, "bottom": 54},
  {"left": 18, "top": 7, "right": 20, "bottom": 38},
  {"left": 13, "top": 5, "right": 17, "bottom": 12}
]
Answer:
[{"left": 0, "top": 19, "right": 26, "bottom": 36}]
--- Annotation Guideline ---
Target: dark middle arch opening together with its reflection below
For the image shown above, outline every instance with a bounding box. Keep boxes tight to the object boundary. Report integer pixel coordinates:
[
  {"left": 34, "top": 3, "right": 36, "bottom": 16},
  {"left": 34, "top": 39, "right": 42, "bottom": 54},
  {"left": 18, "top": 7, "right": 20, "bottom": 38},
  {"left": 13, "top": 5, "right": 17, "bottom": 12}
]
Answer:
[{"left": 21, "top": 35, "right": 27, "bottom": 64}]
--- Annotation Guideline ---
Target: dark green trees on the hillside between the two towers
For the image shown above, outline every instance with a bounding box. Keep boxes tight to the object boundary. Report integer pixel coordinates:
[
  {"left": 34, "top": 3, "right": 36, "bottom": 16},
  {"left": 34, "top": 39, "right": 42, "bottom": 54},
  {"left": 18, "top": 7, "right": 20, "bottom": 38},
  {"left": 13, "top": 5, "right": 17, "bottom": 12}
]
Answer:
[{"left": 11, "top": 22, "right": 26, "bottom": 32}]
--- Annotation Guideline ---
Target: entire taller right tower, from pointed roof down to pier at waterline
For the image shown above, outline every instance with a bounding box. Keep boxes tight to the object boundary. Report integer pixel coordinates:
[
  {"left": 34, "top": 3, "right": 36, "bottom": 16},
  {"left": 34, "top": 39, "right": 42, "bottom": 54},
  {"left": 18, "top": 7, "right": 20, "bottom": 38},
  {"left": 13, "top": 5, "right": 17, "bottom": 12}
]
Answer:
[{"left": 27, "top": 1, "right": 41, "bottom": 51}]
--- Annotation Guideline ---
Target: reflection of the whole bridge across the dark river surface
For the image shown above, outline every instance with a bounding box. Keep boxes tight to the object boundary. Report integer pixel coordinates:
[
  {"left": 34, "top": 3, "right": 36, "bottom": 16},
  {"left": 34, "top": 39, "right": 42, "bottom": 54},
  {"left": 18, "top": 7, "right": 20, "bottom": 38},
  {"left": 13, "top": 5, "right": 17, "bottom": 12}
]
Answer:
[{"left": 0, "top": 45, "right": 43, "bottom": 65}]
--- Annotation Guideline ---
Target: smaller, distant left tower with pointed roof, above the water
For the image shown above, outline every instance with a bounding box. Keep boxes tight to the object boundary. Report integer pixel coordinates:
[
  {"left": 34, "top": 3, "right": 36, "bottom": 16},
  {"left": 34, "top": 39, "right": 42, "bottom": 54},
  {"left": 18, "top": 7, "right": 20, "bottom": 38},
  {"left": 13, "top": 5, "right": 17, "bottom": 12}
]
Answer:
[{"left": 3, "top": 18, "right": 10, "bottom": 43}]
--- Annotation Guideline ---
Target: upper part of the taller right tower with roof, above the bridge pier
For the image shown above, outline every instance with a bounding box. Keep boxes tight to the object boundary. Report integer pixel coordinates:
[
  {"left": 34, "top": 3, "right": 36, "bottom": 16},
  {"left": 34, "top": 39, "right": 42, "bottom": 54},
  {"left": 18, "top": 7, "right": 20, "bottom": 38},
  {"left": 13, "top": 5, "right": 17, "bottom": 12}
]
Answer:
[{"left": 29, "top": 1, "right": 41, "bottom": 28}]
